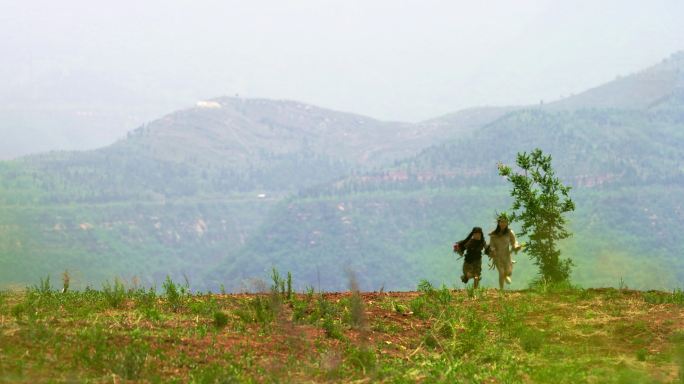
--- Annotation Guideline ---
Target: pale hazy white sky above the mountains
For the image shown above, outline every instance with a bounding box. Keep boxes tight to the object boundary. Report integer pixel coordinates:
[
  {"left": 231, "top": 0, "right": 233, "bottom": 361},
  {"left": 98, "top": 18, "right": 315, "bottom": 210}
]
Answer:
[{"left": 0, "top": 0, "right": 684, "bottom": 159}]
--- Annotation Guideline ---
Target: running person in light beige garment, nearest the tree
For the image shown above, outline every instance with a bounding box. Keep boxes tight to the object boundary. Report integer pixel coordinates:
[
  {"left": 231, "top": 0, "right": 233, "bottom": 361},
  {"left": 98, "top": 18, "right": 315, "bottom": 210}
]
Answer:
[{"left": 489, "top": 214, "right": 522, "bottom": 289}]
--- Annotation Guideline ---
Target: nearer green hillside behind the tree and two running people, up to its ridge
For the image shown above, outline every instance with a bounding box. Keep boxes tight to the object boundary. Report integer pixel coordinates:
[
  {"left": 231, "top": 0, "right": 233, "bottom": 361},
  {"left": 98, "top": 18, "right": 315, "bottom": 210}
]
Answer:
[{"left": 208, "top": 109, "right": 684, "bottom": 290}]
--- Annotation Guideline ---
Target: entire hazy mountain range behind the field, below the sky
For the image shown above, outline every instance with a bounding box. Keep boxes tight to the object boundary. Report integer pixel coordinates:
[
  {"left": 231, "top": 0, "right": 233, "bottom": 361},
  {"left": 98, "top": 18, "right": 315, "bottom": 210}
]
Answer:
[{"left": 0, "top": 52, "right": 684, "bottom": 291}]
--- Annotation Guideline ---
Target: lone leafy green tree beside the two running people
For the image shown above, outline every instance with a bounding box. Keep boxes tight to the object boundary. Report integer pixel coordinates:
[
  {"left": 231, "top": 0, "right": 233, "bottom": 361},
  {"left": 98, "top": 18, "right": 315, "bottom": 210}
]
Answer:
[{"left": 498, "top": 148, "right": 575, "bottom": 282}]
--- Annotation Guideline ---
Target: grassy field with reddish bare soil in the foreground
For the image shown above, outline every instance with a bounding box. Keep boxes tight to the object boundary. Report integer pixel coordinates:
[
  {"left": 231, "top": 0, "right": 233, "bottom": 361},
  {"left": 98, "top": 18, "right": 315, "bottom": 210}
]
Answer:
[{"left": 0, "top": 274, "right": 684, "bottom": 383}]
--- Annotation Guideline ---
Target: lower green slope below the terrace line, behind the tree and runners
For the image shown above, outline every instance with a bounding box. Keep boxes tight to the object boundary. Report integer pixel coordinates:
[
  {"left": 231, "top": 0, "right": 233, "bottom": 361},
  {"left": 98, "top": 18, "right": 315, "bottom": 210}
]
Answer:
[{"left": 205, "top": 186, "right": 684, "bottom": 290}]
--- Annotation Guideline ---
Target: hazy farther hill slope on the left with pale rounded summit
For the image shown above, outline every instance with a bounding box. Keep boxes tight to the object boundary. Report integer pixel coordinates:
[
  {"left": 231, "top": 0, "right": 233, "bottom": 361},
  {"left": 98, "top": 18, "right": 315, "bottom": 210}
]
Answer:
[{"left": 0, "top": 98, "right": 510, "bottom": 287}]
